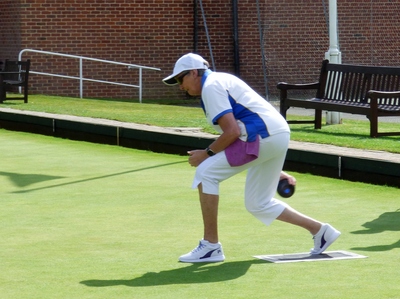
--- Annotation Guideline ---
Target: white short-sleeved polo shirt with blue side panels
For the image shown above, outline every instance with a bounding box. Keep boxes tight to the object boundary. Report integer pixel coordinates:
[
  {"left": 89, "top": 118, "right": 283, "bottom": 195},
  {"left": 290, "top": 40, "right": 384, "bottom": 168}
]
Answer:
[{"left": 201, "top": 70, "right": 290, "bottom": 142}]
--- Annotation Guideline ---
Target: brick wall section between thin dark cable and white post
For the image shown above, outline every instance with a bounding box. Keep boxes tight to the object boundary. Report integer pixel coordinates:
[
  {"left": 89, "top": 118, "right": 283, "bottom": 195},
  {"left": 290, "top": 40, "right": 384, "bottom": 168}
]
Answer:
[{"left": 264, "top": 0, "right": 329, "bottom": 99}]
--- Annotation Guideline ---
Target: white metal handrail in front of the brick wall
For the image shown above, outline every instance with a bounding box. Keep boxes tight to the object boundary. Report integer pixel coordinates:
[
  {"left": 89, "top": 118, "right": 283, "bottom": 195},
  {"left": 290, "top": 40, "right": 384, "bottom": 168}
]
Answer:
[{"left": 18, "top": 49, "right": 161, "bottom": 103}]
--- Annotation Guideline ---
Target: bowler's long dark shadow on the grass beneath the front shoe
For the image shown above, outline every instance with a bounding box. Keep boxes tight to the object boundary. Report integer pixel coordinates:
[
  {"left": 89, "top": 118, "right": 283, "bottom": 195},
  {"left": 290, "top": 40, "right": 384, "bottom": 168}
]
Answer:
[{"left": 80, "top": 260, "right": 266, "bottom": 287}]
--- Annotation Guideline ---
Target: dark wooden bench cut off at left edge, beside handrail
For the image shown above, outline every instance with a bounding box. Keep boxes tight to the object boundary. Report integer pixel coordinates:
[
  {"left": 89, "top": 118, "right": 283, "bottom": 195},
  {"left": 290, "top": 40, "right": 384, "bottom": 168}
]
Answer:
[{"left": 0, "top": 59, "right": 31, "bottom": 103}]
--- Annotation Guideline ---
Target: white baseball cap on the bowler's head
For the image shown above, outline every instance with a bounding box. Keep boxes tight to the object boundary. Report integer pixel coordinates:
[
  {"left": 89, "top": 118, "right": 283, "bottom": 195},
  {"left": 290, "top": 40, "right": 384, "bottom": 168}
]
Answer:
[{"left": 162, "top": 53, "right": 208, "bottom": 85}]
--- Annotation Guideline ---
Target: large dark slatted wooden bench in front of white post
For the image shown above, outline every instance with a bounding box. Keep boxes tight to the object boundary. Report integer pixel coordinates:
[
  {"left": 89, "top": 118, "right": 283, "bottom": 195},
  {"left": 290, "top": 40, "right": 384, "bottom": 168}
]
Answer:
[{"left": 277, "top": 60, "right": 400, "bottom": 137}]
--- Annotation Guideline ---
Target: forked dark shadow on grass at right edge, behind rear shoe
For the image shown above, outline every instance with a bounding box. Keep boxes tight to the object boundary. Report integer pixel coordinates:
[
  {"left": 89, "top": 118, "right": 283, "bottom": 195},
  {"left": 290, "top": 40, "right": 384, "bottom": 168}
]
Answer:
[{"left": 352, "top": 209, "right": 400, "bottom": 251}]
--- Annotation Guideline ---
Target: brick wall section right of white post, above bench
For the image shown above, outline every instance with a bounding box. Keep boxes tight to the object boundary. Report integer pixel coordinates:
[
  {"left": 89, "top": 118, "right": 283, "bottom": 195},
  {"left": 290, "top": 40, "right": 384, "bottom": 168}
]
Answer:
[{"left": 338, "top": 0, "right": 400, "bottom": 66}]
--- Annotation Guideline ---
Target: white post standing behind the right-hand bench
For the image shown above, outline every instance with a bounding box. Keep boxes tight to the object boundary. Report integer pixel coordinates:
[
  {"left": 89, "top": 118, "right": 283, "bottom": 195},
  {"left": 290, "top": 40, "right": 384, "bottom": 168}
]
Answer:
[{"left": 325, "top": 0, "right": 342, "bottom": 125}]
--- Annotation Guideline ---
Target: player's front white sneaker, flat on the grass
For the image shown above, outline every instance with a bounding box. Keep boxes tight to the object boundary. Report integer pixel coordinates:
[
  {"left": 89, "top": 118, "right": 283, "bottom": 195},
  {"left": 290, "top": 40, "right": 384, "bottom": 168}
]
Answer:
[{"left": 179, "top": 240, "right": 225, "bottom": 263}]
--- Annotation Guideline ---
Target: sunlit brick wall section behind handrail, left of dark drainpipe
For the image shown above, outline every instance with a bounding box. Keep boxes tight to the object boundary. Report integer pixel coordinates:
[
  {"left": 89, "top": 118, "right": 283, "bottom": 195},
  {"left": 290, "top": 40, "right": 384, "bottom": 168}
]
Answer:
[{"left": 17, "top": 0, "right": 197, "bottom": 99}]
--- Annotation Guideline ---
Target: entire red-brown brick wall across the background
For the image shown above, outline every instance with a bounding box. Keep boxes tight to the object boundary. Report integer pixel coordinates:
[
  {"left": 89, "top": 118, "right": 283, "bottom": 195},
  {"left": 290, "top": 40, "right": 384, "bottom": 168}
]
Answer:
[{"left": 0, "top": 0, "right": 400, "bottom": 100}]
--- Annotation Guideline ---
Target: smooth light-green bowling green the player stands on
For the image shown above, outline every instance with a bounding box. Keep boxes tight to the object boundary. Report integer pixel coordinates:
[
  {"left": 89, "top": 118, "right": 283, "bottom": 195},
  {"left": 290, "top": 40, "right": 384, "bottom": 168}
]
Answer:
[{"left": 0, "top": 130, "right": 400, "bottom": 299}]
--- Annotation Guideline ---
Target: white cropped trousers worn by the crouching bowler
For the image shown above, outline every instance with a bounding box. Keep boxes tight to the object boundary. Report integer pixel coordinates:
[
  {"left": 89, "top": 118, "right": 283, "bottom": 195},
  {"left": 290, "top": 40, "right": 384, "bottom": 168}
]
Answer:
[{"left": 192, "top": 132, "right": 290, "bottom": 225}]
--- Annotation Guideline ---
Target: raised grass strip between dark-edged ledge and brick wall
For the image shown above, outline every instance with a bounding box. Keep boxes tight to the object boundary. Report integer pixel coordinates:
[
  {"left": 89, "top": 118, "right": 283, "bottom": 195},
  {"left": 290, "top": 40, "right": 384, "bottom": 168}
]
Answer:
[{"left": 0, "top": 95, "right": 400, "bottom": 153}]
